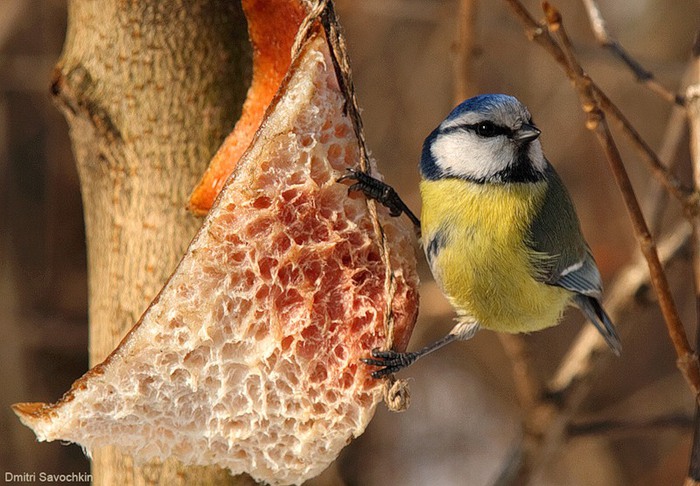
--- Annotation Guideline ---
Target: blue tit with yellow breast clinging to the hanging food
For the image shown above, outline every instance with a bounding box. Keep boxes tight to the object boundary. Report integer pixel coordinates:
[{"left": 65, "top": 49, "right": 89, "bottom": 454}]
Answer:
[{"left": 344, "top": 94, "right": 621, "bottom": 377}]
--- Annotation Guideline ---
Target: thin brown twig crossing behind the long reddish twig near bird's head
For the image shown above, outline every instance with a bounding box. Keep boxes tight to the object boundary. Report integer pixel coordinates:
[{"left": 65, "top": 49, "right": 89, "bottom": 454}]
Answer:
[{"left": 505, "top": 0, "right": 700, "bottom": 214}]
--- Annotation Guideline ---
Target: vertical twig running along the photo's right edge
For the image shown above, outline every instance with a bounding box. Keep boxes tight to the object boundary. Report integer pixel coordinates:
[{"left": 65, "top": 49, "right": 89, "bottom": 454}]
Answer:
[{"left": 686, "top": 31, "right": 700, "bottom": 485}]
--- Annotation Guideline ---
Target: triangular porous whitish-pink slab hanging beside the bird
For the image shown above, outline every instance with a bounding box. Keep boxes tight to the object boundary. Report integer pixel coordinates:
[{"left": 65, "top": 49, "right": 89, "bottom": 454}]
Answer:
[{"left": 14, "top": 33, "right": 418, "bottom": 484}]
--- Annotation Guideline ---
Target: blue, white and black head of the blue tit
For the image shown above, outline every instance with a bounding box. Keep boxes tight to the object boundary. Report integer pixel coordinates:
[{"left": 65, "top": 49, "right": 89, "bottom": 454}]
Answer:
[{"left": 421, "top": 94, "right": 547, "bottom": 183}]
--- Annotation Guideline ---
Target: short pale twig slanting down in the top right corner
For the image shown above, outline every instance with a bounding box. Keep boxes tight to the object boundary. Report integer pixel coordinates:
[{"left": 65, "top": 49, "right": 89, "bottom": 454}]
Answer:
[{"left": 581, "top": 0, "right": 685, "bottom": 106}]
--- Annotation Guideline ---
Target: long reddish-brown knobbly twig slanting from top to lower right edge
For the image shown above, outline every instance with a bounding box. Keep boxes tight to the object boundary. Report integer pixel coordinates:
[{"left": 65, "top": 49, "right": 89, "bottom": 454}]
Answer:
[{"left": 543, "top": 2, "right": 700, "bottom": 397}]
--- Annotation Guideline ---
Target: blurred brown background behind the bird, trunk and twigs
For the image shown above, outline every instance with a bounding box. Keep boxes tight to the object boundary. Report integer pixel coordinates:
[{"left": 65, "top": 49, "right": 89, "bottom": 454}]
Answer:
[{"left": 0, "top": 0, "right": 700, "bottom": 485}]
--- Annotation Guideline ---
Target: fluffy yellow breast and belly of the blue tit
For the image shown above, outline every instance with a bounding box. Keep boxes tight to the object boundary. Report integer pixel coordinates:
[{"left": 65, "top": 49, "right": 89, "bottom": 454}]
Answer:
[{"left": 421, "top": 179, "right": 571, "bottom": 332}]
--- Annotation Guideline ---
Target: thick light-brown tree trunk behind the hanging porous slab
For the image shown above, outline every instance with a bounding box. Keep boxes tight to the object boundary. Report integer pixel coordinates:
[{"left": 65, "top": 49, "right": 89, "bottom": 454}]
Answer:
[{"left": 52, "top": 0, "right": 251, "bottom": 485}]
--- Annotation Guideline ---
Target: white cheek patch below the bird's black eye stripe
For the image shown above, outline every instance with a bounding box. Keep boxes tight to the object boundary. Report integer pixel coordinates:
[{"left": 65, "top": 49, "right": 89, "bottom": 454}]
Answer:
[{"left": 431, "top": 133, "right": 513, "bottom": 179}]
